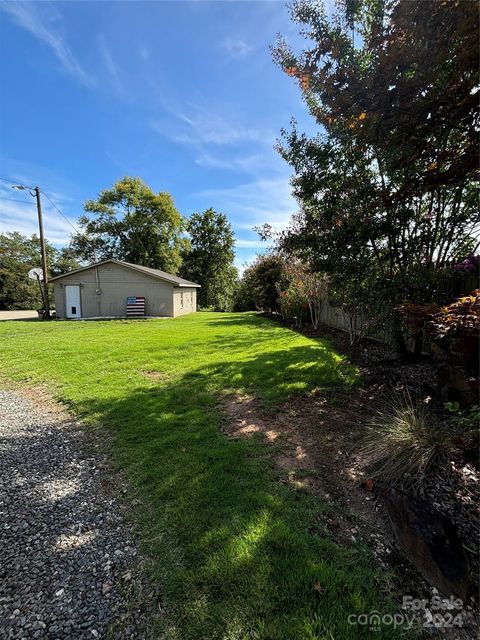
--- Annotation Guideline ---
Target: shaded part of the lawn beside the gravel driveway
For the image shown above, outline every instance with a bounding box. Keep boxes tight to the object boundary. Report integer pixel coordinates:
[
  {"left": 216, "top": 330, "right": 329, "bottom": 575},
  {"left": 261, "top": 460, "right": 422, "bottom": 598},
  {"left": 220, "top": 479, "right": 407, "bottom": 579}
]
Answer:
[{"left": 72, "top": 344, "right": 394, "bottom": 640}]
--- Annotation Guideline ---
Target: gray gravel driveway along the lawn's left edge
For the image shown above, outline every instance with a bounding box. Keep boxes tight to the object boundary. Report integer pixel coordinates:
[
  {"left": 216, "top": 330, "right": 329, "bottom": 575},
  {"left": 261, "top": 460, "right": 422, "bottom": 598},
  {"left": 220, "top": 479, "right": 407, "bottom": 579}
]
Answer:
[{"left": 0, "top": 391, "right": 146, "bottom": 640}]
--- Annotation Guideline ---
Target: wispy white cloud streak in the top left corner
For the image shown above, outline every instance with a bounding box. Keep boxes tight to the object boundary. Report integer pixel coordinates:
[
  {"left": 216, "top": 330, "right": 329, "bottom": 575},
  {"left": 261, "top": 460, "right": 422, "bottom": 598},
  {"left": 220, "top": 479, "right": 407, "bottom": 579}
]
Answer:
[{"left": 0, "top": 2, "right": 95, "bottom": 87}]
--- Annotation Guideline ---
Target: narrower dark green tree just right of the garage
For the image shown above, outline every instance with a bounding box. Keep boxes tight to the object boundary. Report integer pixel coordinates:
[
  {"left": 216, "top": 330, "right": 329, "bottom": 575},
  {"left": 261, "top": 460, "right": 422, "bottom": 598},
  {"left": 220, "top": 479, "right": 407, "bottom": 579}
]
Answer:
[{"left": 181, "top": 209, "right": 238, "bottom": 311}]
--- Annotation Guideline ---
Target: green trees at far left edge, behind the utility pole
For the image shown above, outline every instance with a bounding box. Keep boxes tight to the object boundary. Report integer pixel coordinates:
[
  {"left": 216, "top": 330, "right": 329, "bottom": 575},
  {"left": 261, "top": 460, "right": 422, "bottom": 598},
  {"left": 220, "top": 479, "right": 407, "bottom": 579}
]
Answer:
[{"left": 0, "top": 231, "right": 80, "bottom": 309}]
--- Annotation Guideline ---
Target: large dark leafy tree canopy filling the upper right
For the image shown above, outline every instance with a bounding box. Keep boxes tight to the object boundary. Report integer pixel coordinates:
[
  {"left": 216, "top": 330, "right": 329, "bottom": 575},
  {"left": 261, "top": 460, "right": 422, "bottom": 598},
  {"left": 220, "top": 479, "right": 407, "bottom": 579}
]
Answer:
[{"left": 274, "top": 0, "right": 479, "bottom": 303}]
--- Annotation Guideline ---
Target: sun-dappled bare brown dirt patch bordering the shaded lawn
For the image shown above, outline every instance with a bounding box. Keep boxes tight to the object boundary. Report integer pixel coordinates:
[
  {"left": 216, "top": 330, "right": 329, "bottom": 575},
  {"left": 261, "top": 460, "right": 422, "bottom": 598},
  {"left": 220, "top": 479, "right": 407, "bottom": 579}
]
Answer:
[{"left": 223, "top": 389, "right": 391, "bottom": 544}]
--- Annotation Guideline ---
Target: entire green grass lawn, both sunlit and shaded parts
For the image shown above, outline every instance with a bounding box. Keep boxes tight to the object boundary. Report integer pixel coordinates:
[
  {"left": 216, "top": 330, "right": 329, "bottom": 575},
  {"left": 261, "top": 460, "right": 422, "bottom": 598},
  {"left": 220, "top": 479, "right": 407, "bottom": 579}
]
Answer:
[{"left": 0, "top": 313, "right": 406, "bottom": 640}]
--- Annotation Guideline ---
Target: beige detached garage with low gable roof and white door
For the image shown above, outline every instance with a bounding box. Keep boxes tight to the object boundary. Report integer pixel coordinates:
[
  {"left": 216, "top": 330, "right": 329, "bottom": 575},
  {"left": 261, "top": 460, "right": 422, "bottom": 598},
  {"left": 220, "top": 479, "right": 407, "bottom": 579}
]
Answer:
[{"left": 50, "top": 259, "right": 200, "bottom": 318}]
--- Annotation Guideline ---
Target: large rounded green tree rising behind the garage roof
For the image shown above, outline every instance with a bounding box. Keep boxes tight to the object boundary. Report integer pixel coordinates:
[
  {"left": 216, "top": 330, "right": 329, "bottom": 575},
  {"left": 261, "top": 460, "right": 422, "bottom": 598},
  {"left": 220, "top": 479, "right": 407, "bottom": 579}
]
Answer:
[{"left": 72, "top": 176, "right": 187, "bottom": 274}]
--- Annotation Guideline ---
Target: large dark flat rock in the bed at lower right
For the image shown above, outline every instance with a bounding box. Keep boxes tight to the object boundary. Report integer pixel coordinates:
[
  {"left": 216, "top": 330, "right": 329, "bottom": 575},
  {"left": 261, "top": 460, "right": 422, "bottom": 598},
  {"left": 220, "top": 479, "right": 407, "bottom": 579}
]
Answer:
[{"left": 385, "top": 489, "right": 469, "bottom": 601}]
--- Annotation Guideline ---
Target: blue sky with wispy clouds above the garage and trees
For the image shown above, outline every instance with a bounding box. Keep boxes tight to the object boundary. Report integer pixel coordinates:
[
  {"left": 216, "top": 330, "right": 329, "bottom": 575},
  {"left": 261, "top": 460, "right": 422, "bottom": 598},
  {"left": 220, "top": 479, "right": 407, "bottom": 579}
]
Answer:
[{"left": 0, "top": 1, "right": 313, "bottom": 267}]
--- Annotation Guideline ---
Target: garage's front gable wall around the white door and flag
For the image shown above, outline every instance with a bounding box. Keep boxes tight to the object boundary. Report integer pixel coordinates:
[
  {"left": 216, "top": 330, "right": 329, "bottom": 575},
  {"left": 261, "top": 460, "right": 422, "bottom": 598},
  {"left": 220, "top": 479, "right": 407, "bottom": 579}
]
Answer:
[{"left": 53, "top": 264, "right": 174, "bottom": 318}]
